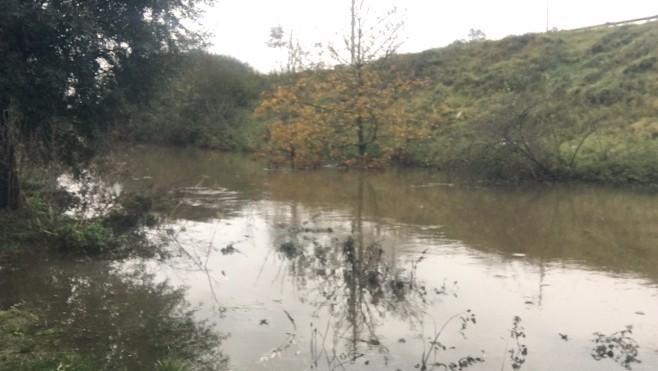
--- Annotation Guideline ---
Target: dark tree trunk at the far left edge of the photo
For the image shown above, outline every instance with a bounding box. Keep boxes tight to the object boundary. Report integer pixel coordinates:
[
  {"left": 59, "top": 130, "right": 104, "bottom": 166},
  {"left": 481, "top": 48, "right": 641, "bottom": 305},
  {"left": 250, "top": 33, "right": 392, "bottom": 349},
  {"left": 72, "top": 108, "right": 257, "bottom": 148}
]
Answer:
[{"left": 0, "top": 107, "right": 20, "bottom": 210}]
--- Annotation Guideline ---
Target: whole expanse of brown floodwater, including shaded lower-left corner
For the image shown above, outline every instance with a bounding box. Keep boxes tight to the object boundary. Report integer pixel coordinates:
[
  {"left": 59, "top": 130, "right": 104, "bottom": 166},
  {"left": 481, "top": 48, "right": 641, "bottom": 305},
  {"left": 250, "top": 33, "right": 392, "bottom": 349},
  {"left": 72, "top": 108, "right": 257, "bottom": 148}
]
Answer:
[{"left": 0, "top": 148, "right": 658, "bottom": 370}]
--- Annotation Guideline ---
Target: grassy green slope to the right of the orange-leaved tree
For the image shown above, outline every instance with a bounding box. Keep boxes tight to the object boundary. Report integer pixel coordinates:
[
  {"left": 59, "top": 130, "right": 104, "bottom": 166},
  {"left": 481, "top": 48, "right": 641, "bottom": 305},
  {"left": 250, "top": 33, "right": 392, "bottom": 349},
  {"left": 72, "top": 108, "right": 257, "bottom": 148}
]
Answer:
[{"left": 395, "top": 22, "right": 658, "bottom": 183}]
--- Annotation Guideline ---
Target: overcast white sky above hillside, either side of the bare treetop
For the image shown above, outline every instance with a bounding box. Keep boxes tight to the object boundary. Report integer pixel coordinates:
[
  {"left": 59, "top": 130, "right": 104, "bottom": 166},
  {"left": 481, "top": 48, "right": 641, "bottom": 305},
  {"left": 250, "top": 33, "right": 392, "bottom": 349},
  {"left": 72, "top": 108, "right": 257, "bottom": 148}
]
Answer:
[{"left": 204, "top": 0, "right": 658, "bottom": 72}]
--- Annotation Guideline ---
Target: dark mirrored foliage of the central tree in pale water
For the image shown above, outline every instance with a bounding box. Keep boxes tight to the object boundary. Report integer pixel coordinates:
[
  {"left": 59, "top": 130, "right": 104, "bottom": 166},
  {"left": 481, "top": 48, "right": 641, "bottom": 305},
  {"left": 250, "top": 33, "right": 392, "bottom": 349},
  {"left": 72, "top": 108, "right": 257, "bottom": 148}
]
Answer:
[{"left": 279, "top": 232, "right": 434, "bottom": 368}]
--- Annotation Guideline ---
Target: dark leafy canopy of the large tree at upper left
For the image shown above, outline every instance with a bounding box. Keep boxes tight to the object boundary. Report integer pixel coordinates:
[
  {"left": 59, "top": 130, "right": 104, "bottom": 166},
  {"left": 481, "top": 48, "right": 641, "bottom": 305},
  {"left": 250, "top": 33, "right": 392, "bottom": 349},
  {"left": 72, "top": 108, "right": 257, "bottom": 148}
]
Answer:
[{"left": 0, "top": 0, "right": 210, "bottom": 209}]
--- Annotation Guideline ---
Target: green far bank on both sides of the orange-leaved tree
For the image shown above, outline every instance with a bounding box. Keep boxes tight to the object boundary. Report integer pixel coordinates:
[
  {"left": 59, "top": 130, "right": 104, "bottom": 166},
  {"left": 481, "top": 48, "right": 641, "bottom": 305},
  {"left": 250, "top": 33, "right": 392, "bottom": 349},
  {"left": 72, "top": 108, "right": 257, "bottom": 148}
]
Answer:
[{"left": 126, "top": 21, "right": 658, "bottom": 185}]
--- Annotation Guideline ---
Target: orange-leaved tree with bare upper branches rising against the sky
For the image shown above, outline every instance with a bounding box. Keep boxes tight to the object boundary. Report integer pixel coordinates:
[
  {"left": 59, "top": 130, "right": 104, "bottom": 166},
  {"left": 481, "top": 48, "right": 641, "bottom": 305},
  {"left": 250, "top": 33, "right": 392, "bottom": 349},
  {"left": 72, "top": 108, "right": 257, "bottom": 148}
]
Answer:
[{"left": 256, "top": 0, "right": 437, "bottom": 167}]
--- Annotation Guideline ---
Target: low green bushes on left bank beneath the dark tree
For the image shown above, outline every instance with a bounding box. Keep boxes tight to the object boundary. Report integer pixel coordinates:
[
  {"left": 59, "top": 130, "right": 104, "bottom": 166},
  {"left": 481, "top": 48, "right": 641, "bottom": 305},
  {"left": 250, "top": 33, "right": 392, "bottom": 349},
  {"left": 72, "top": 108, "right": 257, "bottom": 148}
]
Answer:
[{"left": 0, "top": 166, "right": 158, "bottom": 257}]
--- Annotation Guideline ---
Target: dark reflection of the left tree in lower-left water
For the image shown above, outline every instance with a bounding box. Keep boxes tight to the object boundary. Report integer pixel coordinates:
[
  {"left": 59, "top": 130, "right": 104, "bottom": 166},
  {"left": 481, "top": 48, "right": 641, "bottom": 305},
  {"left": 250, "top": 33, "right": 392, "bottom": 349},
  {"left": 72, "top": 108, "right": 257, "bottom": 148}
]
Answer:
[{"left": 0, "top": 258, "right": 228, "bottom": 370}]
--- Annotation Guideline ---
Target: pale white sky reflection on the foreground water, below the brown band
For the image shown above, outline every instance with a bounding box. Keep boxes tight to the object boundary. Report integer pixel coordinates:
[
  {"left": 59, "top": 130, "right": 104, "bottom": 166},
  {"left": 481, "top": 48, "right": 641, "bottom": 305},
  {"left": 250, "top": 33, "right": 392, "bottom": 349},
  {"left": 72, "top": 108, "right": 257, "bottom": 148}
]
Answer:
[{"left": 127, "top": 201, "right": 658, "bottom": 370}]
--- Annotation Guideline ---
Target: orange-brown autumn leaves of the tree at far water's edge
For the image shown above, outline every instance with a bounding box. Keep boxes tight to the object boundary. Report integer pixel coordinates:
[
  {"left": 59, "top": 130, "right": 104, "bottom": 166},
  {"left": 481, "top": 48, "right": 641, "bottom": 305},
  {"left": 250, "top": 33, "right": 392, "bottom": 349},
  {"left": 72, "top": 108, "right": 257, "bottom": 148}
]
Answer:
[{"left": 256, "top": 64, "right": 439, "bottom": 168}]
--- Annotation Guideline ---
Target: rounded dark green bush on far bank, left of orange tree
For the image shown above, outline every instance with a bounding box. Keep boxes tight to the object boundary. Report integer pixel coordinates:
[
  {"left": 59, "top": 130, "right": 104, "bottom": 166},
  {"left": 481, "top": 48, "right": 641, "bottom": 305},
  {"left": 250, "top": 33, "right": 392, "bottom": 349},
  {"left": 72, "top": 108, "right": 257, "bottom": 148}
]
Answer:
[{"left": 127, "top": 52, "right": 265, "bottom": 150}]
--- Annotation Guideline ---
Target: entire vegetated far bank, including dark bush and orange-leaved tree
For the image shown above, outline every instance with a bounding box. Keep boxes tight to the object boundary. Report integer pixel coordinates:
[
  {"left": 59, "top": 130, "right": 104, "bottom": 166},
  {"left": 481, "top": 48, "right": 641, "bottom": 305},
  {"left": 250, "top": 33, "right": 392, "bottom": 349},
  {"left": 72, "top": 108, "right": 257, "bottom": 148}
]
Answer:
[{"left": 134, "top": 22, "right": 658, "bottom": 184}]
